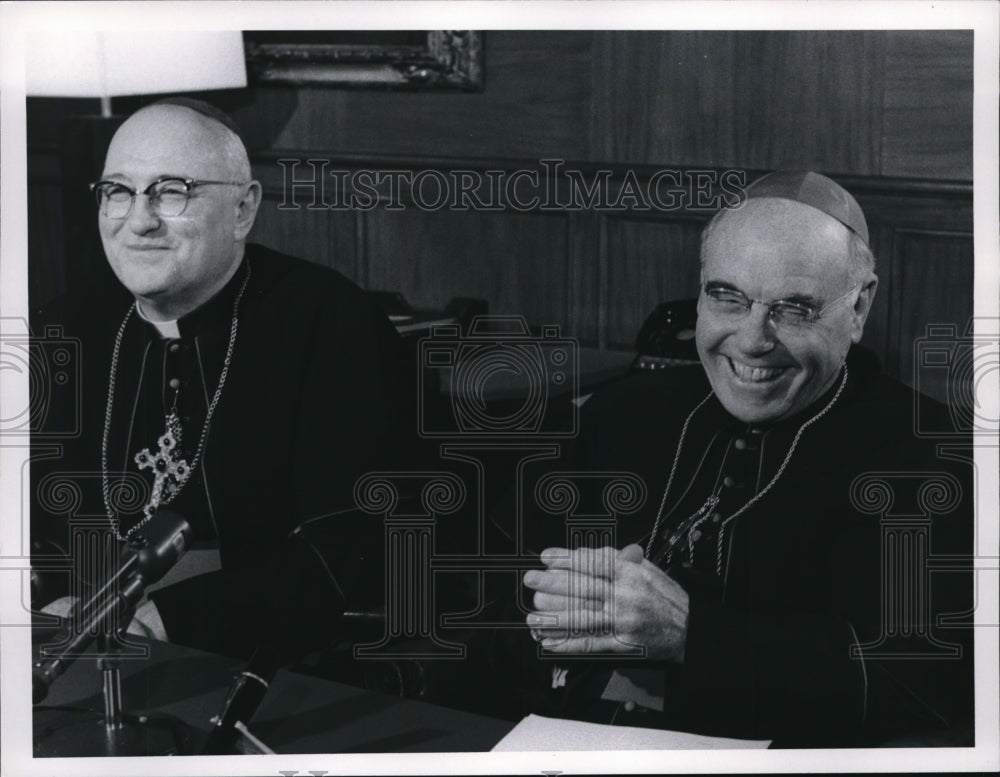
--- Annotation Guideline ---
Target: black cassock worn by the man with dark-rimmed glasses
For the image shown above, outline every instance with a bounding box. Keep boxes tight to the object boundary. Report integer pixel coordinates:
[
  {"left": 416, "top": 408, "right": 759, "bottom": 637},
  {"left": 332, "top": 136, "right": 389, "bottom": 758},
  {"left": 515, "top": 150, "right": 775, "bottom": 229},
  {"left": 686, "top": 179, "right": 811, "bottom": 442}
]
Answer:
[{"left": 31, "top": 245, "right": 414, "bottom": 654}]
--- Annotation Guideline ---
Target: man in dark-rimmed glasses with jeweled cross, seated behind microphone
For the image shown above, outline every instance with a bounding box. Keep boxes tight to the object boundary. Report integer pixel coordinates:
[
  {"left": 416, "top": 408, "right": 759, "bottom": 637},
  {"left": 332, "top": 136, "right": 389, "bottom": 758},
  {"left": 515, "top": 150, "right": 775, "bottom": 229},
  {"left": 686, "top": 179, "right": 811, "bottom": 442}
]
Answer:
[{"left": 32, "top": 98, "right": 409, "bottom": 655}]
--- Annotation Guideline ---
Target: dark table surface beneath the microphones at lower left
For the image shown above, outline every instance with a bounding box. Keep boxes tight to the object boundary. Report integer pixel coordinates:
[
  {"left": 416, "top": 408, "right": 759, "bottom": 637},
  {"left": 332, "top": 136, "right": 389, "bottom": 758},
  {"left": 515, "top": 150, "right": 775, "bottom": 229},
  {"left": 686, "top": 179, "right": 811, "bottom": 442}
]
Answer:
[{"left": 35, "top": 641, "right": 514, "bottom": 755}]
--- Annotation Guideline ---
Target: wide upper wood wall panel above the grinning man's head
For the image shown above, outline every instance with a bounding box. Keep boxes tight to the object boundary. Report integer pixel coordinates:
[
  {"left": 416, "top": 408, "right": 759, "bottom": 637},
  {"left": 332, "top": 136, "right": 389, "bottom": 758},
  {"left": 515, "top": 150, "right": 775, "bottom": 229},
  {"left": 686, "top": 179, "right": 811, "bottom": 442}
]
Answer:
[{"left": 594, "top": 31, "right": 885, "bottom": 174}]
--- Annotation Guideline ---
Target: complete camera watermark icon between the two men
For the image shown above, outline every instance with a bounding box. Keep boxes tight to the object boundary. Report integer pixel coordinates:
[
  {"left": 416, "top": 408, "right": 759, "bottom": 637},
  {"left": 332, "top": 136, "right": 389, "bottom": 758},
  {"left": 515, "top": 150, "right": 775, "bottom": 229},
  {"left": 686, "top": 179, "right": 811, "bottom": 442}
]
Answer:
[{"left": 418, "top": 316, "right": 580, "bottom": 438}]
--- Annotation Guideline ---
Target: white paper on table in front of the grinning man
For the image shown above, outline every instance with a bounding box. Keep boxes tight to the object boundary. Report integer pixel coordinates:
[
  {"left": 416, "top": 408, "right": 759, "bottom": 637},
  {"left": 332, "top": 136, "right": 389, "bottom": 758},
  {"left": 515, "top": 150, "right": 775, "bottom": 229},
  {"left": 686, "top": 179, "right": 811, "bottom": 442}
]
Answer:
[{"left": 493, "top": 715, "right": 771, "bottom": 752}]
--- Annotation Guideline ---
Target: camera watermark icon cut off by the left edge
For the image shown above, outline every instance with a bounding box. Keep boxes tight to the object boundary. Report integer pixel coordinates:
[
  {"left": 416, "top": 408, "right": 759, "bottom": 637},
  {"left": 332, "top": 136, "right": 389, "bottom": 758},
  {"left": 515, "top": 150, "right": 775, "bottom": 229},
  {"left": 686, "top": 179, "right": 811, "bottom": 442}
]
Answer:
[{"left": 0, "top": 318, "right": 82, "bottom": 440}]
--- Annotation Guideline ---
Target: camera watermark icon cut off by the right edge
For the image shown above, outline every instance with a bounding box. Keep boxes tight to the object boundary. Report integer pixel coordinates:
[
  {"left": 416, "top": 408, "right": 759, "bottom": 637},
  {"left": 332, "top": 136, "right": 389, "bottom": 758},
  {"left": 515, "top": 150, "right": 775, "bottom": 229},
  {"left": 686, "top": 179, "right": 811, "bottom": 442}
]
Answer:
[{"left": 913, "top": 318, "right": 1000, "bottom": 438}]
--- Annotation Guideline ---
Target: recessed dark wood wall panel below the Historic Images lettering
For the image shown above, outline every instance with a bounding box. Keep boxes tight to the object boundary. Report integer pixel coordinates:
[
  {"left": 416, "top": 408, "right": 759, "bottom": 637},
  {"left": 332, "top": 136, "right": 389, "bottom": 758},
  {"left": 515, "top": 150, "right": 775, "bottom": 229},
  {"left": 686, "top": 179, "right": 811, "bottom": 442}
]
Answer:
[{"left": 365, "top": 209, "right": 572, "bottom": 334}]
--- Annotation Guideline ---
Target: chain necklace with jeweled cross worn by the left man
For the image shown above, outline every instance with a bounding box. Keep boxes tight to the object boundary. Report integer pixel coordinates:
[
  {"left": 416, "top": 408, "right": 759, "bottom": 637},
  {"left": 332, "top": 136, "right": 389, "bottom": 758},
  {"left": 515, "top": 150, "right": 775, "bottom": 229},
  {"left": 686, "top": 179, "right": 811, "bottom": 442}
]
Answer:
[{"left": 101, "top": 260, "right": 250, "bottom": 542}]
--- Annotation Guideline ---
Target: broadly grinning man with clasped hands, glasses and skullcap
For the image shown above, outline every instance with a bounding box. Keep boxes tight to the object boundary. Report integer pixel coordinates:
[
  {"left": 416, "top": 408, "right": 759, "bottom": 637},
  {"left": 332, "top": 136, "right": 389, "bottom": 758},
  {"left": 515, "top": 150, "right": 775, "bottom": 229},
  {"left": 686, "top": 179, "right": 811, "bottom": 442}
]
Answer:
[{"left": 524, "top": 172, "right": 972, "bottom": 746}]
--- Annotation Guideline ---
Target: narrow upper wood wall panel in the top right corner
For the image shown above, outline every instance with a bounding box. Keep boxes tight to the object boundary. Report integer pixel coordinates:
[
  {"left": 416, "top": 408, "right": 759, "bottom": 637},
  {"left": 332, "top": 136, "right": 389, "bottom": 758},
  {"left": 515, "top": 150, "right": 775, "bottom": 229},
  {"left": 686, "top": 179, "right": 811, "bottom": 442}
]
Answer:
[{"left": 878, "top": 30, "right": 973, "bottom": 181}]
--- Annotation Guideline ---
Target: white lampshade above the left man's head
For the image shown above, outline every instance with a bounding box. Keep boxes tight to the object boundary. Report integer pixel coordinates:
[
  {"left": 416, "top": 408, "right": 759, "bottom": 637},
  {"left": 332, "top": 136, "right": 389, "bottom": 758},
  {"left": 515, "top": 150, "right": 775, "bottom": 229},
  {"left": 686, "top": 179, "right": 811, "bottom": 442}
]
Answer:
[{"left": 25, "top": 30, "right": 247, "bottom": 100}]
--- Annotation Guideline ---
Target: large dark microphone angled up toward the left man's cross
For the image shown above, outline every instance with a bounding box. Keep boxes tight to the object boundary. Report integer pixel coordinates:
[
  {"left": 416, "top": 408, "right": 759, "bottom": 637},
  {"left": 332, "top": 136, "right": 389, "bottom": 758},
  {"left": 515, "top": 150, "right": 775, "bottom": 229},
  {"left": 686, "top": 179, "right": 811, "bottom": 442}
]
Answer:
[{"left": 31, "top": 510, "right": 191, "bottom": 704}]
